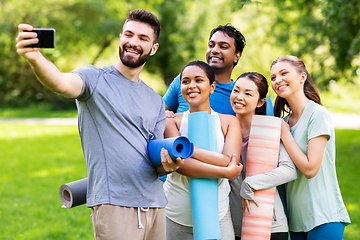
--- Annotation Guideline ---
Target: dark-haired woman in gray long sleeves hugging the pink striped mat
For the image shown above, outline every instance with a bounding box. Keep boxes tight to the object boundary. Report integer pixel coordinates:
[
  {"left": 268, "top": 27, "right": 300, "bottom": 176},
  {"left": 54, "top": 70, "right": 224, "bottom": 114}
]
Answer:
[{"left": 230, "top": 72, "right": 296, "bottom": 240}]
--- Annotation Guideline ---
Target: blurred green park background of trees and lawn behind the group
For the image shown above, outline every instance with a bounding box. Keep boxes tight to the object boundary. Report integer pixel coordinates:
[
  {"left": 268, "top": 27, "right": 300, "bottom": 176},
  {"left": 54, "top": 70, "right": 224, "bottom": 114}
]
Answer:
[{"left": 0, "top": 0, "right": 360, "bottom": 239}]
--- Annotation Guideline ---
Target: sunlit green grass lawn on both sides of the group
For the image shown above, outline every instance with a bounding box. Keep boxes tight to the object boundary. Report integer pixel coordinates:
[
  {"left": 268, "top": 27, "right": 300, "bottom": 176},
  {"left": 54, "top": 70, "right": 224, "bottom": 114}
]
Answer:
[{"left": 0, "top": 122, "right": 360, "bottom": 240}]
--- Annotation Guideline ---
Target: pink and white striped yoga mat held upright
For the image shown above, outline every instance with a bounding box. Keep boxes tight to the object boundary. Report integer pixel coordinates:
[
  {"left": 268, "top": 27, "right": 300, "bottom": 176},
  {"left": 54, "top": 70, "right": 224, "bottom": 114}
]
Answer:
[{"left": 241, "top": 115, "right": 281, "bottom": 240}]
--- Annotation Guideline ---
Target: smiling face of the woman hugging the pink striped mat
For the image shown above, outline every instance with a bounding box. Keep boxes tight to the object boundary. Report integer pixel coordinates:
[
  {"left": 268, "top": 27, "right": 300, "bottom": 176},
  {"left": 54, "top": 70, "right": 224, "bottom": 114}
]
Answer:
[{"left": 230, "top": 77, "right": 265, "bottom": 115}]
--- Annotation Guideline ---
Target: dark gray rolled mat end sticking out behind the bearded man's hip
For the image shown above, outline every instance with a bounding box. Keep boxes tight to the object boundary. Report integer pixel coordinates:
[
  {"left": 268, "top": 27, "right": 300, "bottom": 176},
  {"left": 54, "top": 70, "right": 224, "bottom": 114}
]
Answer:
[{"left": 59, "top": 178, "right": 88, "bottom": 208}]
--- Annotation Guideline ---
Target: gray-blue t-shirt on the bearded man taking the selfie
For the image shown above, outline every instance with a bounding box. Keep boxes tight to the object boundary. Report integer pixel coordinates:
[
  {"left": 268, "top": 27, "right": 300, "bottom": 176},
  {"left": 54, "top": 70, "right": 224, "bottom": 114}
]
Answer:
[{"left": 73, "top": 65, "right": 167, "bottom": 208}]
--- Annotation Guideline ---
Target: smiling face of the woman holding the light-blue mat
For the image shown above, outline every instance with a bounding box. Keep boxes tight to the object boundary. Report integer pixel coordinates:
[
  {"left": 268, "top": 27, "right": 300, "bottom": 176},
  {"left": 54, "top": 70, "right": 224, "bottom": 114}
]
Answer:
[{"left": 180, "top": 65, "right": 216, "bottom": 108}]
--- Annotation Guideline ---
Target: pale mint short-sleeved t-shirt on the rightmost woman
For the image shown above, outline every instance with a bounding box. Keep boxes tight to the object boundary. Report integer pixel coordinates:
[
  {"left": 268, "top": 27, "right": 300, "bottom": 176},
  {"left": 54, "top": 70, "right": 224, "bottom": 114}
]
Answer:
[{"left": 285, "top": 100, "right": 350, "bottom": 232}]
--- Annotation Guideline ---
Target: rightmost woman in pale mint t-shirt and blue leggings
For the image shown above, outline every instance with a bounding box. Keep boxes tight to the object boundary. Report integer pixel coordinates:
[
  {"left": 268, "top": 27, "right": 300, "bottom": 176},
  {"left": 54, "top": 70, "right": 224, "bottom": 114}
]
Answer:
[{"left": 271, "top": 56, "right": 350, "bottom": 240}]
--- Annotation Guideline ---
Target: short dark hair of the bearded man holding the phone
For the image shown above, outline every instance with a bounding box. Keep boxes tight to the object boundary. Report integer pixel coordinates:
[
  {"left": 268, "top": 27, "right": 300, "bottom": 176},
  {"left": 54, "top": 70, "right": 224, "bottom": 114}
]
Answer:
[{"left": 125, "top": 9, "right": 160, "bottom": 42}]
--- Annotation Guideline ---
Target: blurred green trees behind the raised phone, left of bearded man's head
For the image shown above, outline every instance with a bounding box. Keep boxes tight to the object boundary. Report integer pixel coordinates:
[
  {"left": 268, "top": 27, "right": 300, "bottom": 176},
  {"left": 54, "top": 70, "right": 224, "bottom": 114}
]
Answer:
[{"left": 0, "top": 0, "right": 156, "bottom": 106}]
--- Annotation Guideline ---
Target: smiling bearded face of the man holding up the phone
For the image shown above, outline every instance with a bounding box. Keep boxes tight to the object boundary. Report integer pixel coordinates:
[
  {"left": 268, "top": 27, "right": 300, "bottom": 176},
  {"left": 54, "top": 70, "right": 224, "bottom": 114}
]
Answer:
[{"left": 119, "top": 21, "right": 159, "bottom": 68}]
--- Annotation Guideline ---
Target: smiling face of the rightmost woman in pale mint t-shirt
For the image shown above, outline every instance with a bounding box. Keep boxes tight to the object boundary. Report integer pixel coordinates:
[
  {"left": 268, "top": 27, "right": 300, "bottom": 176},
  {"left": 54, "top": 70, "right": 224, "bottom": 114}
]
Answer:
[{"left": 270, "top": 61, "right": 306, "bottom": 99}]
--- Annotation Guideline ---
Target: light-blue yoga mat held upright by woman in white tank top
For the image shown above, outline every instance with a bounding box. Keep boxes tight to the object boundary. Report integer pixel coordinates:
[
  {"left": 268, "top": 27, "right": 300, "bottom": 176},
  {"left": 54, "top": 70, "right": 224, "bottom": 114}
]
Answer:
[{"left": 188, "top": 112, "right": 221, "bottom": 240}]
